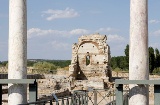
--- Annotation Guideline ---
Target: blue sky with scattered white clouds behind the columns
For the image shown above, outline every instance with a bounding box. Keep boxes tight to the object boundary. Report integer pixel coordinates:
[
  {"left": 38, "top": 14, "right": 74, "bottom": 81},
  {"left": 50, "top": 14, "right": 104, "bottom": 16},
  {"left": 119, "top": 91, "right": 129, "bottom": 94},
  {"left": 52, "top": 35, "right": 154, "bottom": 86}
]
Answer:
[{"left": 0, "top": 0, "right": 160, "bottom": 61}]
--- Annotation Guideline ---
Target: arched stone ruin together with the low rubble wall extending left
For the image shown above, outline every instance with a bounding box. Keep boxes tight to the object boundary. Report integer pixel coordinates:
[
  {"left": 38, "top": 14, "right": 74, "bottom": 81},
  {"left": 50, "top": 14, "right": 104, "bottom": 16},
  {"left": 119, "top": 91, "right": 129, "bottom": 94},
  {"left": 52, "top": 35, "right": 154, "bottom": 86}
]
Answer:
[{"left": 1, "top": 34, "right": 113, "bottom": 103}]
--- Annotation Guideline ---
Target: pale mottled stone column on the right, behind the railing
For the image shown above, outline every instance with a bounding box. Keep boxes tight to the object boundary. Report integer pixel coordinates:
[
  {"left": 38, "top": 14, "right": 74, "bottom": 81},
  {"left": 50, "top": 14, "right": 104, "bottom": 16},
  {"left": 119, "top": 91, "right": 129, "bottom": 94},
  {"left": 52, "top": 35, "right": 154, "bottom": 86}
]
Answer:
[{"left": 129, "top": 0, "right": 149, "bottom": 105}]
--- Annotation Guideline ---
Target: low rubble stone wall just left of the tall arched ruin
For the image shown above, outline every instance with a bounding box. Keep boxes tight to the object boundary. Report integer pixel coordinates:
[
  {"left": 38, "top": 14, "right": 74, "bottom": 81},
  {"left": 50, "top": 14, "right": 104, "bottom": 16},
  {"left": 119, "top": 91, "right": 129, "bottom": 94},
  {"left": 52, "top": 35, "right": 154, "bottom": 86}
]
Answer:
[{"left": 38, "top": 78, "right": 70, "bottom": 98}]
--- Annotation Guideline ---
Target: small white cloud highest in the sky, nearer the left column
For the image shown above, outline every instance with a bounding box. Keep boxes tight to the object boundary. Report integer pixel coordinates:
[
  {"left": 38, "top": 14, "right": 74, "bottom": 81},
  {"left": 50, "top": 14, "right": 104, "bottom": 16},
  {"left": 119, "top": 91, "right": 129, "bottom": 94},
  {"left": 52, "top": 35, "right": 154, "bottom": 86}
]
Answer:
[{"left": 42, "top": 8, "right": 79, "bottom": 21}]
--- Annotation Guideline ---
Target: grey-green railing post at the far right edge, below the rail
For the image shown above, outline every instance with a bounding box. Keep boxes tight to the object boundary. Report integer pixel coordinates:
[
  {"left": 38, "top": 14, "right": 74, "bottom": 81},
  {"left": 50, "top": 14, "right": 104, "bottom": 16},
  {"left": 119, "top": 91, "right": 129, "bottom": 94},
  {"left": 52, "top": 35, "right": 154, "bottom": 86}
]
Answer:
[{"left": 154, "top": 85, "right": 160, "bottom": 105}]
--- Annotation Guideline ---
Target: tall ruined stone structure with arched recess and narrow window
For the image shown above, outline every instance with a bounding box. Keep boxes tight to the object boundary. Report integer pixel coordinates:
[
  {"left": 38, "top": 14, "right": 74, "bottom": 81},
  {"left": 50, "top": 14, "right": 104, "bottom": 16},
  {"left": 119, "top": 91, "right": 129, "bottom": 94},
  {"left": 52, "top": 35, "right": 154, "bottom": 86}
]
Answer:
[{"left": 69, "top": 34, "right": 112, "bottom": 88}]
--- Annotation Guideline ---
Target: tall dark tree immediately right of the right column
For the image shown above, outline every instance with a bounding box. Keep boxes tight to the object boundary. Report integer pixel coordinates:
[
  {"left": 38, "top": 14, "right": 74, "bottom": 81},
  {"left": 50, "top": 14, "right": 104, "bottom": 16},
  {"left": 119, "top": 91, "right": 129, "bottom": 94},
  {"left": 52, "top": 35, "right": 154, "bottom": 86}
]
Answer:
[{"left": 148, "top": 47, "right": 155, "bottom": 73}]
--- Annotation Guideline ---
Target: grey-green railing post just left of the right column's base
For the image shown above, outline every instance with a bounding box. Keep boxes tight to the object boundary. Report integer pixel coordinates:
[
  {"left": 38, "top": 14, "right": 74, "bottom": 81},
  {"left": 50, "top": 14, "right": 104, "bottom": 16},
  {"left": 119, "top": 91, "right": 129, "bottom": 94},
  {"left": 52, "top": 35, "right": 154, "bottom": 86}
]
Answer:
[{"left": 116, "top": 84, "right": 123, "bottom": 105}]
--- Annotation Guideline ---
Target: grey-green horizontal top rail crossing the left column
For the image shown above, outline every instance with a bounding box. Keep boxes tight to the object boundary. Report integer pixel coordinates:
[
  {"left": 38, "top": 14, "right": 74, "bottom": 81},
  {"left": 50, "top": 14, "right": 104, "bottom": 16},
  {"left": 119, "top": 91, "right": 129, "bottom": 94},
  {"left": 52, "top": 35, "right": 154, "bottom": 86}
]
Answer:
[{"left": 0, "top": 79, "right": 36, "bottom": 84}]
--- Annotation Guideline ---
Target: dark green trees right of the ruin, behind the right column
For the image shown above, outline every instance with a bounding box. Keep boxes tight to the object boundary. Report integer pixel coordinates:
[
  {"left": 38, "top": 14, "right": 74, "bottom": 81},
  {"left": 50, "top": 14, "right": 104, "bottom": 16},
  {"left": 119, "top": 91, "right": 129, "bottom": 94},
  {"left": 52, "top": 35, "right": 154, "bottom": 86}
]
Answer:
[{"left": 111, "top": 45, "right": 160, "bottom": 73}]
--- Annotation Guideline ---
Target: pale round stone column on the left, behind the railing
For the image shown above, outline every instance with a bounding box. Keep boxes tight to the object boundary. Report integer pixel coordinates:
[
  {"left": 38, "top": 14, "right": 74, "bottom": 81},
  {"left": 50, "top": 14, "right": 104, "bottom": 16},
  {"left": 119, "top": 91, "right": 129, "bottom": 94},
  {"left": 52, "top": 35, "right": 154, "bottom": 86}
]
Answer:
[{"left": 8, "top": 0, "right": 27, "bottom": 105}]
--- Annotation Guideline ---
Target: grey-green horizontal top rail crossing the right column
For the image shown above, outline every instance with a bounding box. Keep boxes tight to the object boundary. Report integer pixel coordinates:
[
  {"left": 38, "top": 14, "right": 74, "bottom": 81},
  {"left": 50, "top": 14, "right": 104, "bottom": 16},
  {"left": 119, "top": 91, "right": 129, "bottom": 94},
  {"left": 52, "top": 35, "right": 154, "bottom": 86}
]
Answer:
[{"left": 115, "top": 79, "right": 160, "bottom": 85}]
